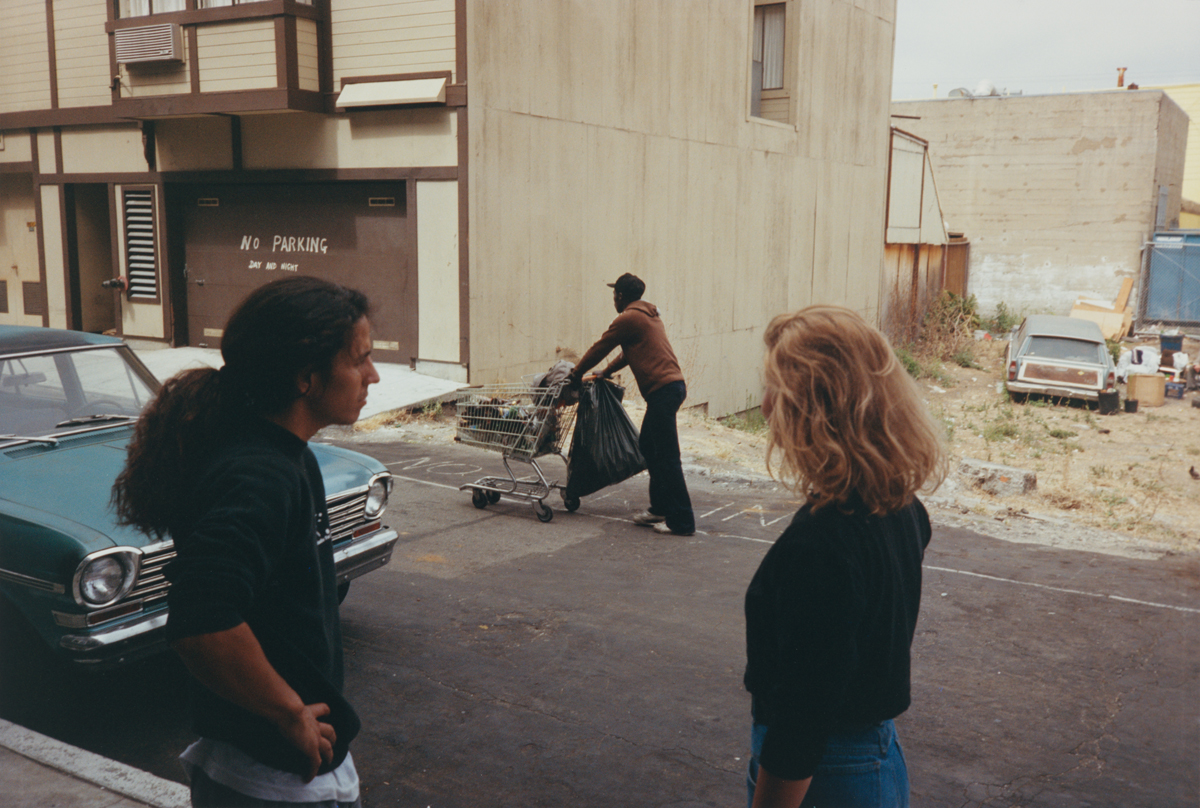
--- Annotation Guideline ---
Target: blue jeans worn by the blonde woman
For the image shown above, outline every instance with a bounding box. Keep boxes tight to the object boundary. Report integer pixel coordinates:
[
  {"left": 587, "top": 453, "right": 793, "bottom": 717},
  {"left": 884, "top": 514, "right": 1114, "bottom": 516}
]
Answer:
[{"left": 746, "top": 720, "right": 908, "bottom": 808}]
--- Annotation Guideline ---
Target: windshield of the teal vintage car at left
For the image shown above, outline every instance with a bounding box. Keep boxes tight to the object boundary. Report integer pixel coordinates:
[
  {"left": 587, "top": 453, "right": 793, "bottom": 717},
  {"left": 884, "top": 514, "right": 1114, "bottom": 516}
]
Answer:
[{"left": 0, "top": 346, "right": 154, "bottom": 437}]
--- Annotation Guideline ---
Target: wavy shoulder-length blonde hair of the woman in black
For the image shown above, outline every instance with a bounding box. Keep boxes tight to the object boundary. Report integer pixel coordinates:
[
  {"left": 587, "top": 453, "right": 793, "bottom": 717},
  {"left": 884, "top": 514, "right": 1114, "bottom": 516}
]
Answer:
[{"left": 763, "top": 306, "right": 947, "bottom": 515}]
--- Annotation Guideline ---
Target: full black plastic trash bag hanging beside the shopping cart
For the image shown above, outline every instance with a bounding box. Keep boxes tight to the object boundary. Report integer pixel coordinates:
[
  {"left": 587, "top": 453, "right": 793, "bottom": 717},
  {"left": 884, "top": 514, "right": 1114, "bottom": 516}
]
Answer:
[{"left": 564, "top": 379, "right": 646, "bottom": 499}]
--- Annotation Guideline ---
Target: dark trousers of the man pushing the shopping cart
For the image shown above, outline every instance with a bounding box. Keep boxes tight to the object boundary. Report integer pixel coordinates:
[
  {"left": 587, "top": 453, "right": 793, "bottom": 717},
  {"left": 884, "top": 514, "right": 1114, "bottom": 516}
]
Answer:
[{"left": 637, "top": 382, "right": 696, "bottom": 533}]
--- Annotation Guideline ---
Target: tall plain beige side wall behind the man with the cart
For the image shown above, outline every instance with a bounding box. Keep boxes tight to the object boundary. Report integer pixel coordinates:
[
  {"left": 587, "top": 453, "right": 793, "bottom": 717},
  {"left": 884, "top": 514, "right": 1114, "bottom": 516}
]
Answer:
[{"left": 467, "top": 0, "right": 895, "bottom": 414}]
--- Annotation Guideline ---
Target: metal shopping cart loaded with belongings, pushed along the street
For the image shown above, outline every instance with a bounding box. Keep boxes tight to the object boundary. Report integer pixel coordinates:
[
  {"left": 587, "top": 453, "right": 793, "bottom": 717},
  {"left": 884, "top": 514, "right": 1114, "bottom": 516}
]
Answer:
[{"left": 455, "top": 377, "right": 580, "bottom": 522}]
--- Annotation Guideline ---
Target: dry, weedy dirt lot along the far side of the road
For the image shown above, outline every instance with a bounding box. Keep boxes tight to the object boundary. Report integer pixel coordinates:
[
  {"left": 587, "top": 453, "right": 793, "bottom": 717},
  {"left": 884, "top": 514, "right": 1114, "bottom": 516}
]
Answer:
[{"left": 350, "top": 340, "right": 1200, "bottom": 557}]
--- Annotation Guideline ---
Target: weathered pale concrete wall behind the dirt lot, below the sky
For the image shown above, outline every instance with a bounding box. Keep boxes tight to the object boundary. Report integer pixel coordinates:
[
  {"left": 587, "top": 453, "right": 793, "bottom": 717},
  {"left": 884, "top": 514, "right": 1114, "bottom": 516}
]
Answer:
[{"left": 892, "top": 90, "right": 1187, "bottom": 315}]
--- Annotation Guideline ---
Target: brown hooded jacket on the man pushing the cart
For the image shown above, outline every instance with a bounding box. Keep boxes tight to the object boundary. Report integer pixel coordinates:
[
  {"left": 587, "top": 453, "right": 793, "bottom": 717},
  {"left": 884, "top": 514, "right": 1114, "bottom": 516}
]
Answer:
[{"left": 575, "top": 300, "right": 683, "bottom": 397}]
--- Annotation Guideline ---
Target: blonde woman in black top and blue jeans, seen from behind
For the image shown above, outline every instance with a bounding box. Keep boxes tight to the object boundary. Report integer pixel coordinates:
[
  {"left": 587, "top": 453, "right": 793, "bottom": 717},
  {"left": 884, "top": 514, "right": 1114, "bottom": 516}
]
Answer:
[{"left": 745, "top": 306, "right": 946, "bottom": 808}]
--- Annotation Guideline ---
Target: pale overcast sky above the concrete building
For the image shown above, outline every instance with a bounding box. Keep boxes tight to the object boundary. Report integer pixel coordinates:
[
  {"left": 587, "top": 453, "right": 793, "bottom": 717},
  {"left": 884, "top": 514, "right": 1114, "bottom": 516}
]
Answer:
[{"left": 892, "top": 0, "right": 1200, "bottom": 101}]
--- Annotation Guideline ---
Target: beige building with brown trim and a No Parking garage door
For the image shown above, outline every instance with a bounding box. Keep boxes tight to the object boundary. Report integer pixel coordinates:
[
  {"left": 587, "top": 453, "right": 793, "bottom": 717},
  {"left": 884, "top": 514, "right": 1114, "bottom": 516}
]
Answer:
[{"left": 0, "top": 0, "right": 895, "bottom": 414}]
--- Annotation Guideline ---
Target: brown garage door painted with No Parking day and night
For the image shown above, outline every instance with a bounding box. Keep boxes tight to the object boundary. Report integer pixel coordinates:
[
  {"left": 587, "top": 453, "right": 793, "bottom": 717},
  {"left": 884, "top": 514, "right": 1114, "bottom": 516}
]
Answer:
[{"left": 176, "top": 182, "right": 418, "bottom": 363}]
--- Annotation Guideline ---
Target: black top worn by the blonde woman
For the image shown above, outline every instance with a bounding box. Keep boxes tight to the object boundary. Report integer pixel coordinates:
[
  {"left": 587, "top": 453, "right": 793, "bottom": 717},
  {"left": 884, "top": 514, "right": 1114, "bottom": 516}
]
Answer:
[{"left": 744, "top": 499, "right": 930, "bottom": 780}]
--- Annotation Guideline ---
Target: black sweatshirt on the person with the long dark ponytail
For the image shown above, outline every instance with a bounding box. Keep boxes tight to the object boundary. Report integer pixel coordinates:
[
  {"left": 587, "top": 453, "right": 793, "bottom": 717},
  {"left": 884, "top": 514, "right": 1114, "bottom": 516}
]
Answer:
[{"left": 166, "top": 419, "right": 359, "bottom": 774}]
